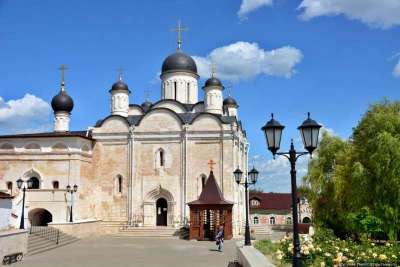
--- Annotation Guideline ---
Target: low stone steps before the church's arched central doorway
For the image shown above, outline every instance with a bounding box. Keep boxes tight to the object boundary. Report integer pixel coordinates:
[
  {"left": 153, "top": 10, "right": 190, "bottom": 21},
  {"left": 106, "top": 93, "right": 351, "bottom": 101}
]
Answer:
[{"left": 113, "top": 225, "right": 179, "bottom": 238}]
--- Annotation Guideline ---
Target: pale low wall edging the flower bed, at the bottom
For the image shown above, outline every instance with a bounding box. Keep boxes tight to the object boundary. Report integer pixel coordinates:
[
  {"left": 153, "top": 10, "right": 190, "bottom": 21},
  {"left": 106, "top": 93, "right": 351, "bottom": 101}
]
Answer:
[{"left": 236, "top": 240, "right": 275, "bottom": 267}]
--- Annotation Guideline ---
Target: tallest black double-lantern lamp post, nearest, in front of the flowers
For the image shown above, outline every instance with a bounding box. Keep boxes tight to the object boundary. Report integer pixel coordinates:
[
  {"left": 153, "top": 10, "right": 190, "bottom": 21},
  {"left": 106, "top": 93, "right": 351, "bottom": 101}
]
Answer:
[{"left": 262, "top": 113, "right": 321, "bottom": 267}]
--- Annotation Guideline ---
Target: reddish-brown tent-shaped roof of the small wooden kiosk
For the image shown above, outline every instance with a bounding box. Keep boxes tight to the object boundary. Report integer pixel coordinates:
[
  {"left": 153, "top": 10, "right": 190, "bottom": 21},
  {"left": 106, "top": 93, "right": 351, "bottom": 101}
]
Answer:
[{"left": 188, "top": 171, "right": 233, "bottom": 206}]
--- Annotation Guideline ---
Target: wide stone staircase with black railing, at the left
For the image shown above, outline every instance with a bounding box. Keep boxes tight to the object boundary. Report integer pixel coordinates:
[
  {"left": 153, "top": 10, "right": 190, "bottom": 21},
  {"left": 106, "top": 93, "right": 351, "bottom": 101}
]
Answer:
[{"left": 27, "top": 226, "right": 79, "bottom": 255}]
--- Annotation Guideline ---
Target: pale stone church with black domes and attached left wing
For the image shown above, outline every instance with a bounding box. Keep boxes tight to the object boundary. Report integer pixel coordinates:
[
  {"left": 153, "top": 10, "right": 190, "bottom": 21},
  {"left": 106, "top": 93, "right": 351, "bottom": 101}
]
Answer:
[{"left": 0, "top": 43, "right": 248, "bottom": 235}]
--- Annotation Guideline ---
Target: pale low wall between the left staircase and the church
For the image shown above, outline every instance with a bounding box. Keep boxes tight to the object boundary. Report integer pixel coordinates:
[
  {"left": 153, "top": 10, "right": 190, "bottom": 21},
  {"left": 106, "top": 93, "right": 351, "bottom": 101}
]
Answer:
[{"left": 49, "top": 220, "right": 104, "bottom": 238}]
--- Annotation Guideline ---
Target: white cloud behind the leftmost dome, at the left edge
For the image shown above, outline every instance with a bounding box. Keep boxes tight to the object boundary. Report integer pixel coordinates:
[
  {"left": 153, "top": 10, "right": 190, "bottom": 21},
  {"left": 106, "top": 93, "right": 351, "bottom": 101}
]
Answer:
[{"left": 0, "top": 94, "right": 51, "bottom": 133}]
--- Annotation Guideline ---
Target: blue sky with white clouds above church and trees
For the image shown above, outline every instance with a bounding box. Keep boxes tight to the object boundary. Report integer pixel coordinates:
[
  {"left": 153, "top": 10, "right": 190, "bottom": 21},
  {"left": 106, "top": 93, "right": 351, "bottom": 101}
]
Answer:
[{"left": 0, "top": 0, "right": 400, "bottom": 192}]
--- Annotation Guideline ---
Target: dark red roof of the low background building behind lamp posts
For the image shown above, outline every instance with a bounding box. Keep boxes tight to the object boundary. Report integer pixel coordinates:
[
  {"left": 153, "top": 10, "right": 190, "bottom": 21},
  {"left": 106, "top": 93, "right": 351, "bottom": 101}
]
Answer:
[{"left": 249, "top": 193, "right": 292, "bottom": 210}]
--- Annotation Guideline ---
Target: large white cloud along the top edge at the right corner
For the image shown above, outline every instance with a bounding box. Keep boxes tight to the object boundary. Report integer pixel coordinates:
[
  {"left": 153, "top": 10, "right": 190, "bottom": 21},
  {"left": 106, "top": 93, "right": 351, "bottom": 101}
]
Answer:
[{"left": 299, "top": 0, "right": 400, "bottom": 29}]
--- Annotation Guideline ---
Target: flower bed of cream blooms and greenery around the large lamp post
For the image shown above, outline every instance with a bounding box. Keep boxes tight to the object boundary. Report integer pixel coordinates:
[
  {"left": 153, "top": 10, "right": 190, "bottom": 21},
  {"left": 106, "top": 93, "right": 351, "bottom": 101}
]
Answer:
[{"left": 256, "top": 229, "right": 400, "bottom": 267}]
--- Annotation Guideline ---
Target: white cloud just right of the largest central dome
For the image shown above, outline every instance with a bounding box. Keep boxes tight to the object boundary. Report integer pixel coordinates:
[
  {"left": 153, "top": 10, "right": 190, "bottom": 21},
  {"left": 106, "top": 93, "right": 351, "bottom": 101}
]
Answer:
[{"left": 193, "top": 41, "right": 303, "bottom": 80}]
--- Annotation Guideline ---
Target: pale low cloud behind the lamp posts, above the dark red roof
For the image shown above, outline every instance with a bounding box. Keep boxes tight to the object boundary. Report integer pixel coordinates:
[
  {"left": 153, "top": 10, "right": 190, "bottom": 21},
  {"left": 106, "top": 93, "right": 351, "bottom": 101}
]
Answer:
[{"left": 250, "top": 155, "right": 309, "bottom": 193}]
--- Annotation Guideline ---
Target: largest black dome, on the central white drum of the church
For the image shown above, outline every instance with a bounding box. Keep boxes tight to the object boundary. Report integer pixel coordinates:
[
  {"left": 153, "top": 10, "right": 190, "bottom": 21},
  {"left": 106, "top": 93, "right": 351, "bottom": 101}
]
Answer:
[{"left": 161, "top": 50, "right": 197, "bottom": 74}]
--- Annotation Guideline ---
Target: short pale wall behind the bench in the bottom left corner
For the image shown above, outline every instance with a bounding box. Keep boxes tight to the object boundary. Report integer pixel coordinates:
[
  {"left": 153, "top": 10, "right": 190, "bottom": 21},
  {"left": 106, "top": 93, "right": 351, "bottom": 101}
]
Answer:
[{"left": 0, "top": 229, "right": 28, "bottom": 262}]
